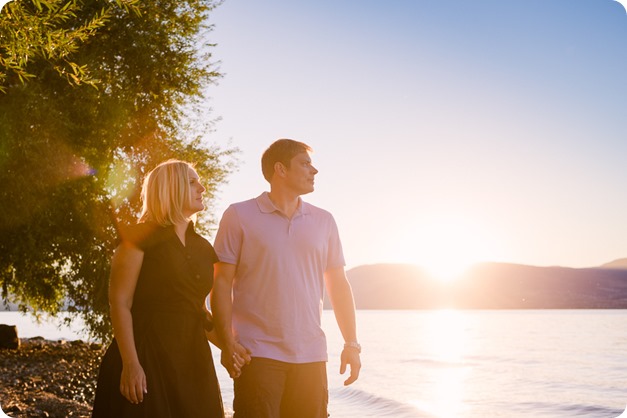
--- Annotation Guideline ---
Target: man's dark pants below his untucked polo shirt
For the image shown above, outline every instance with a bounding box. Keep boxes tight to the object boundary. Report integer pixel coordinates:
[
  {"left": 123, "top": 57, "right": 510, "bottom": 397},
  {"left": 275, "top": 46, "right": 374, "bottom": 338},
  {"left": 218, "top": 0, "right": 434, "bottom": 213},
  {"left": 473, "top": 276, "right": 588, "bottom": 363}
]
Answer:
[{"left": 233, "top": 357, "right": 329, "bottom": 418}]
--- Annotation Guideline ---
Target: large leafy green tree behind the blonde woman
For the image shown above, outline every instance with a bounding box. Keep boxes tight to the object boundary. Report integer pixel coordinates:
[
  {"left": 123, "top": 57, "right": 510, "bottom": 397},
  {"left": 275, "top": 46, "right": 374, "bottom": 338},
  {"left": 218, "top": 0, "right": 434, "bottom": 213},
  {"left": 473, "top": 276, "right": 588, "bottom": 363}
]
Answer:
[{"left": 0, "top": 0, "right": 236, "bottom": 338}]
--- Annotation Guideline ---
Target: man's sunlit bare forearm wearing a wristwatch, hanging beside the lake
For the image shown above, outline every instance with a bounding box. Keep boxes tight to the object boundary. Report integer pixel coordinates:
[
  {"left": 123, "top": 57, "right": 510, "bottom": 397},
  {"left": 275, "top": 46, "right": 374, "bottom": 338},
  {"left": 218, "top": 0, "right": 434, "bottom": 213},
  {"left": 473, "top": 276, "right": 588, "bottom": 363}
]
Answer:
[{"left": 324, "top": 267, "right": 361, "bottom": 386}]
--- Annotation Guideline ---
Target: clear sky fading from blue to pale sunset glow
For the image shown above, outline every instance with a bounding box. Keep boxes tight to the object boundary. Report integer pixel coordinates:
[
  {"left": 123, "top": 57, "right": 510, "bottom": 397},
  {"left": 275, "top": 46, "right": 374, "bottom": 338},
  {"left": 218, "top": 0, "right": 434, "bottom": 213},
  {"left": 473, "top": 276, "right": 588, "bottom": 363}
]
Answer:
[{"left": 208, "top": 0, "right": 627, "bottom": 269}]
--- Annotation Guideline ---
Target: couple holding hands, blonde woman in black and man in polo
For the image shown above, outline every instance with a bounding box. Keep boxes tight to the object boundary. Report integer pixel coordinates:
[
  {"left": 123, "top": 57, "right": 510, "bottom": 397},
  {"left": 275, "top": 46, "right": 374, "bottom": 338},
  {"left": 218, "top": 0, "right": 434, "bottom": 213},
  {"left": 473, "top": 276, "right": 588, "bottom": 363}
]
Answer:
[{"left": 92, "top": 139, "right": 361, "bottom": 418}]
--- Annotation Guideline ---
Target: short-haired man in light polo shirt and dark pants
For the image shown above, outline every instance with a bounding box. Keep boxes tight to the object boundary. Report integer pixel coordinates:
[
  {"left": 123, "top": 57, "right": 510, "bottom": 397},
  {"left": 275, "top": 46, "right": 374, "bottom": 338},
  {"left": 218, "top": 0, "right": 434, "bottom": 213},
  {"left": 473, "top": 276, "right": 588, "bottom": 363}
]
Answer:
[{"left": 211, "top": 139, "right": 361, "bottom": 418}]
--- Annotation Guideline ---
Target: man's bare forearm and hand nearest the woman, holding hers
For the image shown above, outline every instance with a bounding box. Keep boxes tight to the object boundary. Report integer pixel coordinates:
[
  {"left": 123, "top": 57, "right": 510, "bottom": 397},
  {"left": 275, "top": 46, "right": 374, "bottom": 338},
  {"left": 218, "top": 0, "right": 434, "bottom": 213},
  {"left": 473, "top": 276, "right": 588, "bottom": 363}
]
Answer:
[{"left": 211, "top": 262, "right": 250, "bottom": 378}]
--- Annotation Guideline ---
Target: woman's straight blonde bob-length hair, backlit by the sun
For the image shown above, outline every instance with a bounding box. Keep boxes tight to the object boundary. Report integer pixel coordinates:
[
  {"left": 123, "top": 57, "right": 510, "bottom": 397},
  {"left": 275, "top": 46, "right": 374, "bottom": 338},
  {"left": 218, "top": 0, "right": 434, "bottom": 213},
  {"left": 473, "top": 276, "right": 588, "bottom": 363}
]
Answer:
[{"left": 139, "top": 159, "right": 194, "bottom": 226}]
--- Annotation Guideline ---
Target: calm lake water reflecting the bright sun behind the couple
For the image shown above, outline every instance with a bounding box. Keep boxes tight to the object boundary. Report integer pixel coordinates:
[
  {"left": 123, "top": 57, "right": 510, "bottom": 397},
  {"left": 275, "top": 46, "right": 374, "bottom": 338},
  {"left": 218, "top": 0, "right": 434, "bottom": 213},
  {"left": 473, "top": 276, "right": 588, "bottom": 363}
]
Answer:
[{"left": 0, "top": 310, "right": 627, "bottom": 418}]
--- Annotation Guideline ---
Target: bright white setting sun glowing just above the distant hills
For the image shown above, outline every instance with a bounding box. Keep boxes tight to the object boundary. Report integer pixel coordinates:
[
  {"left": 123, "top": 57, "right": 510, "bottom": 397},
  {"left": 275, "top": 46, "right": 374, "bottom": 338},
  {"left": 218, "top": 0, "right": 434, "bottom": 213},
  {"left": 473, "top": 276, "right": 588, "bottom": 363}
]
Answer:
[{"left": 403, "top": 216, "right": 497, "bottom": 281}]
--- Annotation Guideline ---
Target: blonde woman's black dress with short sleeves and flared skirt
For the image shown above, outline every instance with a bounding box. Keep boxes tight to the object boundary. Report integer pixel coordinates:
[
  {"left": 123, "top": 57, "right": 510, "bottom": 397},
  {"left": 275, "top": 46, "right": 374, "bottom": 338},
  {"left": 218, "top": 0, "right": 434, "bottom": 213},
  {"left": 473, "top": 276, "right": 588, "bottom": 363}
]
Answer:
[{"left": 92, "top": 223, "right": 224, "bottom": 418}]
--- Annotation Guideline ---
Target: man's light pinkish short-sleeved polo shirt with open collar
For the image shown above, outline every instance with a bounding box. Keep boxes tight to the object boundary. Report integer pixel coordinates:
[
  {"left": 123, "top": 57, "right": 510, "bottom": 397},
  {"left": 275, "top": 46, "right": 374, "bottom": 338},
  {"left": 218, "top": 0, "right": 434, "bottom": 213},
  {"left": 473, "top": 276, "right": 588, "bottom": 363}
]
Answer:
[{"left": 214, "top": 192, "right": 344, "bottom": 363}]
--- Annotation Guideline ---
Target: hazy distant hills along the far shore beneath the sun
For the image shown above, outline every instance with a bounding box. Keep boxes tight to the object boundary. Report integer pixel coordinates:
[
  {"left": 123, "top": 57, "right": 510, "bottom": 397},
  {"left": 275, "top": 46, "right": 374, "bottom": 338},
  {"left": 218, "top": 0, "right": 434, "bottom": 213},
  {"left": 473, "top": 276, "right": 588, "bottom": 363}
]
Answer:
[{"left": 326, "top": 263, "right": 627, "bottom": 309}]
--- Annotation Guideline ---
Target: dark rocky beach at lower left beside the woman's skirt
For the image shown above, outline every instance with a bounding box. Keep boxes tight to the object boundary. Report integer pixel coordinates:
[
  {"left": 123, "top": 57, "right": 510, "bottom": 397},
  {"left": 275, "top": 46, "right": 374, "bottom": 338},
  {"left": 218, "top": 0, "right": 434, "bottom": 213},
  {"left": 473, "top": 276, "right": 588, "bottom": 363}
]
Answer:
[{"left": 0, "top": 337, "right": 104, "bottom": 418}]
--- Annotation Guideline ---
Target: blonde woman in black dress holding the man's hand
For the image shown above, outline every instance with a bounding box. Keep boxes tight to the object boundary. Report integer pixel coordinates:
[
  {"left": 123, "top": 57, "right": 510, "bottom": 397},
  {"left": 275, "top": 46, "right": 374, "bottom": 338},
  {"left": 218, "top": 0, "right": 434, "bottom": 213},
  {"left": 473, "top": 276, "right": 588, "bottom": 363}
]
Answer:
[{"left": 92, "top": 160, "right": 245, "bottom": 418}]
